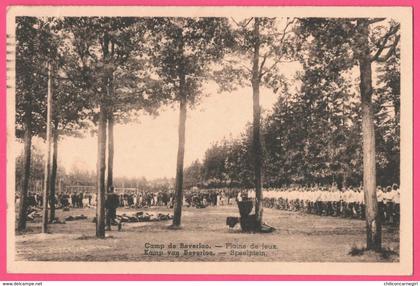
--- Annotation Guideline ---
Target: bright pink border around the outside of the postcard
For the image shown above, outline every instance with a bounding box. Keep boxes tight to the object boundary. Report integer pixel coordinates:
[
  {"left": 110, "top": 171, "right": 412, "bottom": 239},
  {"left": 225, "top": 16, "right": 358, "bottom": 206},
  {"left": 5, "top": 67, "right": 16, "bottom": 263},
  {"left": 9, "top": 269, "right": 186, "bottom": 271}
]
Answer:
[{"left": 0, "top": 0, "right": 420, "bottom": 281}]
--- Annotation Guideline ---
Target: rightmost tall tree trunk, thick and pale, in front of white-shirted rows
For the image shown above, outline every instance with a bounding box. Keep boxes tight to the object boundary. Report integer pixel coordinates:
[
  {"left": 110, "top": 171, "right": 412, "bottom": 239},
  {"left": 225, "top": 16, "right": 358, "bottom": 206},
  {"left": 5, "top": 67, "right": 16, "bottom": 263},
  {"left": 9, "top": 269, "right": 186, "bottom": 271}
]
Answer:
[{"left": 358, "top": 22, "right": 382, "bottom": 250}]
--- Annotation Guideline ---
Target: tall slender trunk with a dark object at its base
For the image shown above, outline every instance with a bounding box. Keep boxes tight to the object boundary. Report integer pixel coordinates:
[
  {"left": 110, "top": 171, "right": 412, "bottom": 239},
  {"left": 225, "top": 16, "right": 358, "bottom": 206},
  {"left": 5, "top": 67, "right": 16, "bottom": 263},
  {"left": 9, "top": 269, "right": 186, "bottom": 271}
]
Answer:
[{"left": 252, "top": 18, "right": 263, "bottom": 227}]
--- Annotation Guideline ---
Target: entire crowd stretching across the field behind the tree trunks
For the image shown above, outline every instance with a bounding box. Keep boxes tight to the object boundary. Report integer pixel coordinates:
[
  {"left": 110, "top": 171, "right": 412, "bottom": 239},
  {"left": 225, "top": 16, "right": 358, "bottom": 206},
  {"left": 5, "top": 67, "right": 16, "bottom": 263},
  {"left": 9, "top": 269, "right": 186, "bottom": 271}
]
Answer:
[{"left": 17, "top": 184, "right": 400, "bottom": 224}]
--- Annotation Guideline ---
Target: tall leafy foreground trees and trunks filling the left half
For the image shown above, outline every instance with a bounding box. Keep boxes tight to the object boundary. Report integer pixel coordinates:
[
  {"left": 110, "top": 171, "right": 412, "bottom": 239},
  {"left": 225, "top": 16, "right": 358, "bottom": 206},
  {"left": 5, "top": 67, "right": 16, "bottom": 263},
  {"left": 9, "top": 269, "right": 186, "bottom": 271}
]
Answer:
[{"left": 16, "top": 17, "right": 233, "bottom": 237}]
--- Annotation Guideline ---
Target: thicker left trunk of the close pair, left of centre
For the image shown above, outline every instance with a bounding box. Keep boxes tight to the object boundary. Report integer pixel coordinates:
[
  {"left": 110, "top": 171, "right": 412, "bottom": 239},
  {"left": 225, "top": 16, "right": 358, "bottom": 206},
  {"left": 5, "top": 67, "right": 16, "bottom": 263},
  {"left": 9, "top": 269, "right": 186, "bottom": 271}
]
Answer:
[{"left": 96, "top": 103, "right": 106, "bottom": 238}]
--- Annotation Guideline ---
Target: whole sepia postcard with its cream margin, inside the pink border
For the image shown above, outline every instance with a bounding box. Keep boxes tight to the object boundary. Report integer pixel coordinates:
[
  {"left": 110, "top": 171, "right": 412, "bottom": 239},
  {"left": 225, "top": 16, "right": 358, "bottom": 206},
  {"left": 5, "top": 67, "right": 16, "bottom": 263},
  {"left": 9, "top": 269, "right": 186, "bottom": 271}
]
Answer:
[{"left": 7, "top": 6, "right": 413, "bottom": 275}]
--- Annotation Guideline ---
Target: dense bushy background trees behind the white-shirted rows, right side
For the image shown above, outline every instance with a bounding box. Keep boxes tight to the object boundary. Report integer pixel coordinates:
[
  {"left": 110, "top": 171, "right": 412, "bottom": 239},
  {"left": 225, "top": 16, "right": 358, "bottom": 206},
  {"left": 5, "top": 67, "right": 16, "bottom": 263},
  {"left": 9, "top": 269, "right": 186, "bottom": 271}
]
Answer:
[{"left": 185, "top": 35, "right": 400, "bottom": 188}]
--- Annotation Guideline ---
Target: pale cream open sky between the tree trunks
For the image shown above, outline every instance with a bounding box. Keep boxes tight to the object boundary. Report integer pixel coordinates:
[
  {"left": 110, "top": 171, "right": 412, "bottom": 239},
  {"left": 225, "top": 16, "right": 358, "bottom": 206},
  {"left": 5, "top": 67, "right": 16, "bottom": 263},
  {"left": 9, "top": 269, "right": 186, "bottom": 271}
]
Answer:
[{"left": 24, "top": 80, "right": 294, "bottom": 179}]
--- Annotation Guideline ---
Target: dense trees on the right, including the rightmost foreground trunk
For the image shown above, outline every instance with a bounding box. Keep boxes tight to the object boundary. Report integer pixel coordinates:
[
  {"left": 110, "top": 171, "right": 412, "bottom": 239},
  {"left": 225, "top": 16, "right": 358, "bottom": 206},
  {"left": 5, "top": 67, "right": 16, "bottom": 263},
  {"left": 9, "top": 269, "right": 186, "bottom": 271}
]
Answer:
[{"left": 187, "top": 19, "right": 400, "bottom": 249}]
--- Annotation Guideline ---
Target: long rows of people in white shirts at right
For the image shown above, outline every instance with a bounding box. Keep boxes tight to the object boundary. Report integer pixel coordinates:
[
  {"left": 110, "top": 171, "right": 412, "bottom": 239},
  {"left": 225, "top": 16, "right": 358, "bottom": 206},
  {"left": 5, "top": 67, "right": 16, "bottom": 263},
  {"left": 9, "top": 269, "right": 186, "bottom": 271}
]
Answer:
[{"left": 260, "top": 184, "right": 400, "bottom": 224}]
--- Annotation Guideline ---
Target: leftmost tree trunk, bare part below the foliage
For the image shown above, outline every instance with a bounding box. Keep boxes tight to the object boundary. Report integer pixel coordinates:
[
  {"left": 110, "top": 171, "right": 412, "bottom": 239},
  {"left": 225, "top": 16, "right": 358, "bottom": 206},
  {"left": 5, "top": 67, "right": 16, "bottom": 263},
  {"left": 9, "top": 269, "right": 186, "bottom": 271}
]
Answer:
[{"left": 17, "top": 108, "right": 32, "bottom": 231}]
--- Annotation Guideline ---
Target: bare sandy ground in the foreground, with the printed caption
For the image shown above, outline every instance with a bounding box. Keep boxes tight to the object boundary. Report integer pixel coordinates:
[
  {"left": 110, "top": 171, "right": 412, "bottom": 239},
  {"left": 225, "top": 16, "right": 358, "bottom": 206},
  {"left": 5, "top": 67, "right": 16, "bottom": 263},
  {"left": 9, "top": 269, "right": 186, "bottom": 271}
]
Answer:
[{"left": 16, "top": 206, "right": 399, "bottom": 262}]
